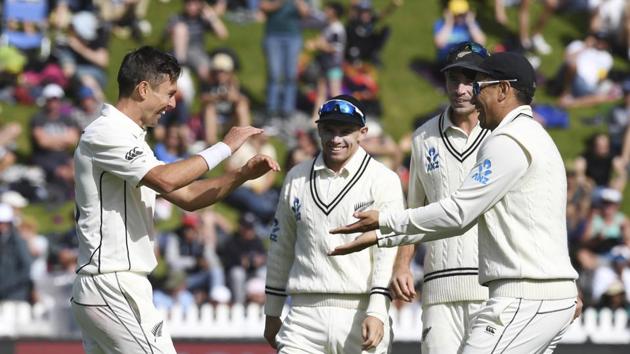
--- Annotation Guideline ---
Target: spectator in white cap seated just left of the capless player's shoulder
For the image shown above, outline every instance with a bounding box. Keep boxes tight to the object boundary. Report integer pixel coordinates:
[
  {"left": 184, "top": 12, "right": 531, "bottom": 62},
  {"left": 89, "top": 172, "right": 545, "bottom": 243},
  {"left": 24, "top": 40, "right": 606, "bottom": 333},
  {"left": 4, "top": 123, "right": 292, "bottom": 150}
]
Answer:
[{"left": 30, "top": 84, "right": 80, "bottom": 201}]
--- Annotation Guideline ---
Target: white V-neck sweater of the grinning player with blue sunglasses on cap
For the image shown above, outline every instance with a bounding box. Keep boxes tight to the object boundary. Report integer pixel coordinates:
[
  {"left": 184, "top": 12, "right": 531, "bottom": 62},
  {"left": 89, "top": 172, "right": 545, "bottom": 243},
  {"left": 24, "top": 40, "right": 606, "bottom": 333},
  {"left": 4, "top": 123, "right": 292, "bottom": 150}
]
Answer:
[{"left": 265, "top": 147, "right": 404, "bottom": 323}]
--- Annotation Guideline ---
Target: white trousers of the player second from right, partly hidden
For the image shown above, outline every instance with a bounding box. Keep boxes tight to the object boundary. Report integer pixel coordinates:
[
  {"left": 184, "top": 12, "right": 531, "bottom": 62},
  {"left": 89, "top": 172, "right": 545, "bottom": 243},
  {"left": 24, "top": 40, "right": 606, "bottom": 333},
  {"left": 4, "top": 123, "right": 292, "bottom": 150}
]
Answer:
[{"left": 421, "top": 301, "right": 483, "bottom": 354}]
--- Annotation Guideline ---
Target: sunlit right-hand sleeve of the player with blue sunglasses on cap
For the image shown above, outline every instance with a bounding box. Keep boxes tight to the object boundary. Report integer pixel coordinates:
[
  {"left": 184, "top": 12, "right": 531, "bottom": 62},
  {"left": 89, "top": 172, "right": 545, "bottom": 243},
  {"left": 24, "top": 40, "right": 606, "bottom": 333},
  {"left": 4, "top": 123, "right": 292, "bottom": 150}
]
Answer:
[{"left": 366, "top": 171, "right": 405, "bottom": 323}]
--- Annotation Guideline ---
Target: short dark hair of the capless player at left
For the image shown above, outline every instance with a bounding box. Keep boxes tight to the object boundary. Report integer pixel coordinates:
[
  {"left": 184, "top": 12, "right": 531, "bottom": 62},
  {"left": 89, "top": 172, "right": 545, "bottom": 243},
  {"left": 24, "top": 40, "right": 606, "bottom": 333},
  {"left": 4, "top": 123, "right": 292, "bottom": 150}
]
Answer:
[{"left": 118, "top": 46, "right": 181, "bottom": 97}]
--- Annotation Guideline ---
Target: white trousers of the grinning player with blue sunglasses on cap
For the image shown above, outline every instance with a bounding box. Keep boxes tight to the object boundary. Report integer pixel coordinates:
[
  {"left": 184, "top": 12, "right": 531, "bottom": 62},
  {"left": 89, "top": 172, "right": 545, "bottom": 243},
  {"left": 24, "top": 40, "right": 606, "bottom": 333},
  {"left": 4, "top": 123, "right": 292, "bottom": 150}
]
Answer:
[{"left": 276, "top": 295, "right": 392, "bottom": 354}]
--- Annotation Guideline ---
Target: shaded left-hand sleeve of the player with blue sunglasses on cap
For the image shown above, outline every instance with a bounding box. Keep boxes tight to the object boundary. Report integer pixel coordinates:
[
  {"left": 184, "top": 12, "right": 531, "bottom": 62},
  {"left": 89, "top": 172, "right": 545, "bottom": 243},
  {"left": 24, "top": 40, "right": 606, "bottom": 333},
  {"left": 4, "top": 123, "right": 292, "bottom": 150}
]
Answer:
[{"left": 265, "top": 176, "right": 296, "bottom": 316}]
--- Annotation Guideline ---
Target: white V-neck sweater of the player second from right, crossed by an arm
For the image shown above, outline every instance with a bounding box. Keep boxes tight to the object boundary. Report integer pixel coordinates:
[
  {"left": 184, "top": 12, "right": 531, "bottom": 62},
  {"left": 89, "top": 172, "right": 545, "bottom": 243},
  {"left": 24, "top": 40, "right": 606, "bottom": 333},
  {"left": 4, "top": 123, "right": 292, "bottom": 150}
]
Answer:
[{"left": 407, "top": 107, "right": 490, "bottom": 305}]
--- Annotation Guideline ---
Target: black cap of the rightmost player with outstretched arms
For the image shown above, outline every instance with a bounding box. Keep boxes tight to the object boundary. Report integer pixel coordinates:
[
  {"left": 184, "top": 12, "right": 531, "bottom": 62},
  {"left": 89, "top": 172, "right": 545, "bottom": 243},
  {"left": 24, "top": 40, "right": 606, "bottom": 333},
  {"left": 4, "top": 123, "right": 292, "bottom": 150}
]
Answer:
[{"left": 473, "top": 52, "right": 536, "bottom": 97}]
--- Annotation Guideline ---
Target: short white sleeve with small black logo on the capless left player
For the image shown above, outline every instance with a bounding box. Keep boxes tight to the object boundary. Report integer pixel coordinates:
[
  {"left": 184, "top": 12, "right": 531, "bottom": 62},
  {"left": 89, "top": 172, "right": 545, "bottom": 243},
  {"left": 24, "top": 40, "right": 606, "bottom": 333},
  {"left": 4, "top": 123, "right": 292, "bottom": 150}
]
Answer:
[{"left": 89, "top": 132, "right": 164, "bottom": 186}]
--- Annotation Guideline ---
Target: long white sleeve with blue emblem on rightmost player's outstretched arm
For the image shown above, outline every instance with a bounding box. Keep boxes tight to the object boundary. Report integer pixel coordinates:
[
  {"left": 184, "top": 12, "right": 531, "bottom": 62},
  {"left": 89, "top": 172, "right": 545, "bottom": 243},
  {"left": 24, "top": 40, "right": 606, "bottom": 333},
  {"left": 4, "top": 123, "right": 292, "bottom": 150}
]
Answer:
[{"left": 378, "top": 135, "right": 529, "bottom": 247}]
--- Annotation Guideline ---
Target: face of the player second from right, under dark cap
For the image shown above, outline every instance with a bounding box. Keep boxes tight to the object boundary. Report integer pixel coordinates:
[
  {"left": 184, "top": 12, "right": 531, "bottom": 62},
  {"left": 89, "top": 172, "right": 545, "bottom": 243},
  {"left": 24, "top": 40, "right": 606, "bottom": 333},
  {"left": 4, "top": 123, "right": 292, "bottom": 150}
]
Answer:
[{"left": 446, "top": 68, "right": 475, "bottom": 116}]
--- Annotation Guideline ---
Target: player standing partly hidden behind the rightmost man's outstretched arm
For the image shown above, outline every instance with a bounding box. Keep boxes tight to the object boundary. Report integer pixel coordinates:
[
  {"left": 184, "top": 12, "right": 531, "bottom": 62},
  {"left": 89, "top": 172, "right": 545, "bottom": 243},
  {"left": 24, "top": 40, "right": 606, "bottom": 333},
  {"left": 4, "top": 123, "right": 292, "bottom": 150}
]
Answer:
[{"left": 391, "top": 42, "right": 490, "bottom": 354}]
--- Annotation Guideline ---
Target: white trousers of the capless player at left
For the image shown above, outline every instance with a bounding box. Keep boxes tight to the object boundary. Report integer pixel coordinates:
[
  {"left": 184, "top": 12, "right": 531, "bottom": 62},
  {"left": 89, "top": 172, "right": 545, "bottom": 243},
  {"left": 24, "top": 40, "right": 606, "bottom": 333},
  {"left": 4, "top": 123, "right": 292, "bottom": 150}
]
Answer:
[{"left": 71, "top": 272, "right": 176, "bottom": 354}]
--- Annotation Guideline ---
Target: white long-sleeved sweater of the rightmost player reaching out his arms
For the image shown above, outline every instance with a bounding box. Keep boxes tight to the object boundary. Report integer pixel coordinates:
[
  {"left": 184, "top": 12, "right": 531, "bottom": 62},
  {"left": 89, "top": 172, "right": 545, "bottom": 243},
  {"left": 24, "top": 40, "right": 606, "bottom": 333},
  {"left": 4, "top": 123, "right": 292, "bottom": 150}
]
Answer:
[{"left": 378, "top": 106, "right": 577, "bottom": 299}]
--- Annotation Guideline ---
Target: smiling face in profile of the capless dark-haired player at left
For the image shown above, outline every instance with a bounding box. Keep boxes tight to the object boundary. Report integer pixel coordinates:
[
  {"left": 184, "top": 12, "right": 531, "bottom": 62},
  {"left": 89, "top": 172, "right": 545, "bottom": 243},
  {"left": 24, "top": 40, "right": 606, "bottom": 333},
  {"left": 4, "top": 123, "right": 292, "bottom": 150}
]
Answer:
[{"left": 138, "top": 76, "right": 177, "bottom": 127}]
